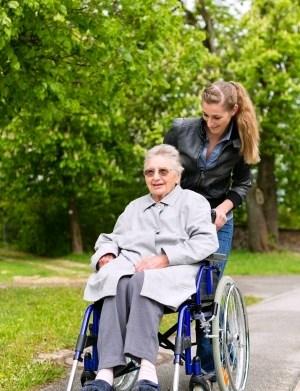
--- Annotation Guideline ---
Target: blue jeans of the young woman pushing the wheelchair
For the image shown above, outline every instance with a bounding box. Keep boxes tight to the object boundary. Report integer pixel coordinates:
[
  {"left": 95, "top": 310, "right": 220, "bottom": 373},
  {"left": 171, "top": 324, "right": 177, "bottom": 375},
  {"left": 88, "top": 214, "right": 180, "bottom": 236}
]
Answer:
[{"left": 197, "top": 218, "right": 233, "bottom": 372}]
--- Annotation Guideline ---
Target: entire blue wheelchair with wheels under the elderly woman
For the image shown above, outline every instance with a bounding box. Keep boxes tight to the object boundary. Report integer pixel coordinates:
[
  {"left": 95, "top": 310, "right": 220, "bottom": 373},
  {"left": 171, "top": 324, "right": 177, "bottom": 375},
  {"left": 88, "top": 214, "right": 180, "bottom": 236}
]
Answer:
[{"left": 67, "top": 253, "right": 250, "bottom": 391}]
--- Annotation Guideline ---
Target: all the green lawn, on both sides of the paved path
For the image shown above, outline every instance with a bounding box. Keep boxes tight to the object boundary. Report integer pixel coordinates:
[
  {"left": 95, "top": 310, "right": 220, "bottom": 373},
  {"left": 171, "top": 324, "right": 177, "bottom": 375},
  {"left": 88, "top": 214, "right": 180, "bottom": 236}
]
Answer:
[{"left": 0, "top": 249, "right": 300, "bottom": 391}]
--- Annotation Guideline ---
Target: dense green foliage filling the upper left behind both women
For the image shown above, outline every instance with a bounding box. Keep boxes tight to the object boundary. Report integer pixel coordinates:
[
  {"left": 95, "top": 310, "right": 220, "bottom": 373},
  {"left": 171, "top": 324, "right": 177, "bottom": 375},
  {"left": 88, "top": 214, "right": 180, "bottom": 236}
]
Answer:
[{"left": 0, "top": 0, "right": 210, "bottom": 254}]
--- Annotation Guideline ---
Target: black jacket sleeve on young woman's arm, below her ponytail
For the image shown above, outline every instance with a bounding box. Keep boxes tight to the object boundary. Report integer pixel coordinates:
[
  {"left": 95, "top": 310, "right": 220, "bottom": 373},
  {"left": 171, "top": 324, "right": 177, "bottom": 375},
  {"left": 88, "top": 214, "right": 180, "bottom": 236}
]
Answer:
[{"left": 227, "top": 158, "right": 251, "bottom": 208}]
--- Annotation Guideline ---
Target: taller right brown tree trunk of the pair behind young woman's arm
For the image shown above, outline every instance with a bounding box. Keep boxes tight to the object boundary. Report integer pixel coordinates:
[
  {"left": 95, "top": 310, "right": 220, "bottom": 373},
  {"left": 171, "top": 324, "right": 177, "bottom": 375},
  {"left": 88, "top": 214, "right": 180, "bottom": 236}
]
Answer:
[{"left": 257, "top": 155, "right": 279, "bottom": 247}]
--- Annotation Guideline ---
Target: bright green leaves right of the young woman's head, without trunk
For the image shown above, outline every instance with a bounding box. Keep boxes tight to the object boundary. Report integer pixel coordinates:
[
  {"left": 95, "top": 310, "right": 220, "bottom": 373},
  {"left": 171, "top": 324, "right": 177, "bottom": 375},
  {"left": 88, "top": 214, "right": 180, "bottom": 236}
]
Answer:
[{"left": 229, "top": 0, "right": 300, "bottom": 227}]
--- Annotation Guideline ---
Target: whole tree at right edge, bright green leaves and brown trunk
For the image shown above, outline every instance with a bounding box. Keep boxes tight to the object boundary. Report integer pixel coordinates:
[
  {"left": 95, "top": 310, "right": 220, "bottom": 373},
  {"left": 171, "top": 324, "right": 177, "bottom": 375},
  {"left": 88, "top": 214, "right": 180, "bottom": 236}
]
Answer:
[{"left": 229, "top": 0, "right": 300, "bottom": 250}]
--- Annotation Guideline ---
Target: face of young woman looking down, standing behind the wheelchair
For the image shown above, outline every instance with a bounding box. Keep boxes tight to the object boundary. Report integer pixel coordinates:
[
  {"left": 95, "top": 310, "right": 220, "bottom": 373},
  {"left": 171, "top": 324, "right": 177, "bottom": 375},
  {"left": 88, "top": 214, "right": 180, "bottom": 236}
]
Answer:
[{"left": 202, "top": 102, "right": 237, "bottom": 137}]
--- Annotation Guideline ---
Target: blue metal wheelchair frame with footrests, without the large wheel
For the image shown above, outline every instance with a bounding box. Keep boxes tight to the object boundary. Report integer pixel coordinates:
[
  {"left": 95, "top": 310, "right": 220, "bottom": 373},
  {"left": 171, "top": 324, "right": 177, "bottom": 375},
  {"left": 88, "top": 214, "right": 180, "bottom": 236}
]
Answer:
[{"left": 67, "top": 253, "right": 225, "bottom": 391}]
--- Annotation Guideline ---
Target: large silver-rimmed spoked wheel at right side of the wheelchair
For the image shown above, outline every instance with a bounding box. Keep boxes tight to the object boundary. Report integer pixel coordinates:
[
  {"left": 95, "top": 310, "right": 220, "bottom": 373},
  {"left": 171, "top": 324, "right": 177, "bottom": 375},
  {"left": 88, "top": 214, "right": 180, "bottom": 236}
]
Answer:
[{"left": 212, "top": 276, "right": 249, "bottom": 391}]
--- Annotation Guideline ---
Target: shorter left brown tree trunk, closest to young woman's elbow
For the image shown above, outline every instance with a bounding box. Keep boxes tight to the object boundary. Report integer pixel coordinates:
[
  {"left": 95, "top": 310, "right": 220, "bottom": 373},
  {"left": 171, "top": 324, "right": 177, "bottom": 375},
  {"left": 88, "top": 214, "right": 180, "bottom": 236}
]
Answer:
[{"left": 247, "top": 185, "right": 269, "bottom": 252}]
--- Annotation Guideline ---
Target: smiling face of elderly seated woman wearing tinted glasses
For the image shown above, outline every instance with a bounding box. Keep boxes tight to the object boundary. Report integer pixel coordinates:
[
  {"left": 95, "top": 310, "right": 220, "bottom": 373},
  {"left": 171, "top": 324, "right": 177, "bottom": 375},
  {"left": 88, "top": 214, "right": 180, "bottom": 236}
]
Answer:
[{"left": 144, "top": 155, "right": 180, "bottom": 201}]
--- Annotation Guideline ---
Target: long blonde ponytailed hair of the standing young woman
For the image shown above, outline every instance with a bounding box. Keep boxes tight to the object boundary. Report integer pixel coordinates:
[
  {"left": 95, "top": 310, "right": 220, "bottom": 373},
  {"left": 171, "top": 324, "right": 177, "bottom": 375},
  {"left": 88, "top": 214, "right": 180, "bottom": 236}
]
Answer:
[{"left": 202, "top": 80, "right": 260, "bottom": 164}]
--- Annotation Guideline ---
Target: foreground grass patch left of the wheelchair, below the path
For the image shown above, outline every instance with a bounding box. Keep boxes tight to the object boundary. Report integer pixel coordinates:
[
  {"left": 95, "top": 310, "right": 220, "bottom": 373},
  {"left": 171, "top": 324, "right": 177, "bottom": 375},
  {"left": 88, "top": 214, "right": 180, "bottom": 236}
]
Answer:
[{"left": 0, "top": 288, "right": 86, "bottom": 391}]
